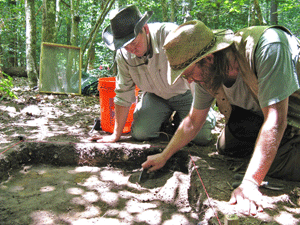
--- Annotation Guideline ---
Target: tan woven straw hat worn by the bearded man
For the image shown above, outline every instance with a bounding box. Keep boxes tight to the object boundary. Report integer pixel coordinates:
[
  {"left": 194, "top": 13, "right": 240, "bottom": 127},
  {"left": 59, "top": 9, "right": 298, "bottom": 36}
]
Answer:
[{"left": 164, "top": 20, "right": 234, "bottom": 84}]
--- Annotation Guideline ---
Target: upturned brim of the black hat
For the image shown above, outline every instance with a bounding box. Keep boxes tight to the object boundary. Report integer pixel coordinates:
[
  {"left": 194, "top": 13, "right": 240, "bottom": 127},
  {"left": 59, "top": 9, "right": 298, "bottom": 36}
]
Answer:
[{"left": 102, "top": 11, "right": 153, "bottom": 51}]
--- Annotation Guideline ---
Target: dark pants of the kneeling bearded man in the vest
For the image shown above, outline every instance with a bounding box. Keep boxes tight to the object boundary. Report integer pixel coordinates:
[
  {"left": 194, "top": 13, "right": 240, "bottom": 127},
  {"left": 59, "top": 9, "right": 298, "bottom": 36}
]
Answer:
[{"left": 217, "top": 106, "right": 300, "bottom": 181}]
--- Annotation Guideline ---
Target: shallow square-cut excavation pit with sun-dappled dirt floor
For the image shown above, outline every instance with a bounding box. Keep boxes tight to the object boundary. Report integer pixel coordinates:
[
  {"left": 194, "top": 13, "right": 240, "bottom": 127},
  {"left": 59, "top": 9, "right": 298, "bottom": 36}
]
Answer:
[{"left": 0, "top": 142, "right": 198, "bottom": 225}]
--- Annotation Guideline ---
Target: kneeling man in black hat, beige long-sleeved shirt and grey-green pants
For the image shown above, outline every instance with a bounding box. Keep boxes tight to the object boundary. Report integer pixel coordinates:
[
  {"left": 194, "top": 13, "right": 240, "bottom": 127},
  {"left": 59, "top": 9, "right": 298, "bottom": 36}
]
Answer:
[{"left": 93, "top": 5, "right": 215, "bottom": 145}]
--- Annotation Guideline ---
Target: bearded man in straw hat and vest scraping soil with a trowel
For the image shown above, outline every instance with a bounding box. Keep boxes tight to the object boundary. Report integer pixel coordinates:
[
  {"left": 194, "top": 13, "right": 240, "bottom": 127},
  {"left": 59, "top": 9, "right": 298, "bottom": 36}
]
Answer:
[{"left": 142, "top": 21, "right": 300, "bottom": 215}]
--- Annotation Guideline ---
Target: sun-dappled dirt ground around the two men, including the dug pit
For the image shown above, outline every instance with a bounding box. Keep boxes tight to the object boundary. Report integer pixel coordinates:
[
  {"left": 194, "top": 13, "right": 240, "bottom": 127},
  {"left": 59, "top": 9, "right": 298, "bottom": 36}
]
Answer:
[{"left": 0, "top": 78, "right": 300, "bottom": 225}]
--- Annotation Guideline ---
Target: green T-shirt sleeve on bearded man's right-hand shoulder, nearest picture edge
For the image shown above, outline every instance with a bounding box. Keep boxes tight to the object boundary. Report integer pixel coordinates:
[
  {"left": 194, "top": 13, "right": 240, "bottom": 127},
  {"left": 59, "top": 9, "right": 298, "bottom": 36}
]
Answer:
[{"left": 255, "top": 29, "right": 299, "bottom": 108}]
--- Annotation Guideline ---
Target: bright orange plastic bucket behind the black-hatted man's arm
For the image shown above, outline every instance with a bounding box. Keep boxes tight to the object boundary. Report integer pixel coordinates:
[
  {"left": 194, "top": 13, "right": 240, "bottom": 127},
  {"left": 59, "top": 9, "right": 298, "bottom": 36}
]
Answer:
[{"left": 98, "top": 77, "right": 139, "bottom": 133}]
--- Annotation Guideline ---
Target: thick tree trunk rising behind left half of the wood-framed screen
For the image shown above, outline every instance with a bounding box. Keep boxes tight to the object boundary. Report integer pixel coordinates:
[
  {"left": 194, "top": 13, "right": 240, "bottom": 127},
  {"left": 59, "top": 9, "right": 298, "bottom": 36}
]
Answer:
[{"left": 42, "top": 0, "right": 57, "bottom": 43}]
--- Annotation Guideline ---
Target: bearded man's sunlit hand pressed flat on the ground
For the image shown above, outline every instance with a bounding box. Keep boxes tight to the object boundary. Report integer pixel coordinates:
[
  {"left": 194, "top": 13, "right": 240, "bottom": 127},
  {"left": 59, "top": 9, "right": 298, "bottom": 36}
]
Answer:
[{"left": 229, "top": 181, "right": 263, "bottom": 216}]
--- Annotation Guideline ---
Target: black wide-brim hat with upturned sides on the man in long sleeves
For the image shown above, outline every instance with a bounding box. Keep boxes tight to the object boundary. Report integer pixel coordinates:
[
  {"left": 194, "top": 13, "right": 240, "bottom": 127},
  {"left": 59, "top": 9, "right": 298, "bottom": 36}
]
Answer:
[{"left": 102, "top": 5, "right": 153, "bottom": 51}]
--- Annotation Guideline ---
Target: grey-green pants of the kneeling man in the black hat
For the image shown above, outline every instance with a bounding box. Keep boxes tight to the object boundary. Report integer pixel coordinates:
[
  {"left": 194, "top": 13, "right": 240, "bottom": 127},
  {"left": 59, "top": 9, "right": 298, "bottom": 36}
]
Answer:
[{"left": 131, "top": 90, "right": 216, "bottom": 145}]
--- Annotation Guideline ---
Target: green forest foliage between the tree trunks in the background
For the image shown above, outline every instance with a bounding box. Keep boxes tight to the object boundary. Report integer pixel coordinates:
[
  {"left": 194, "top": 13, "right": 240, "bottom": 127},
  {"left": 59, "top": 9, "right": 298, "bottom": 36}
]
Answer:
[{"left": 0, "top": 0, "right": 300, "bottom": 72}]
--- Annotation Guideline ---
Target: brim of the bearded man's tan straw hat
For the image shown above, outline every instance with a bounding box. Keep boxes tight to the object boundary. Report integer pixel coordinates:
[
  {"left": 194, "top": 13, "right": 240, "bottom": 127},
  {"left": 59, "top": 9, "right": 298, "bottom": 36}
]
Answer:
[{"left": 167, "top": 30, "right": 233, "bottom": 85}]
